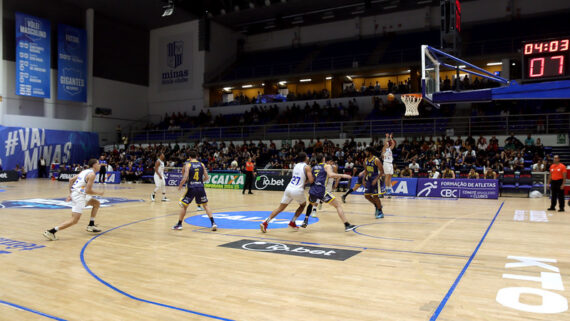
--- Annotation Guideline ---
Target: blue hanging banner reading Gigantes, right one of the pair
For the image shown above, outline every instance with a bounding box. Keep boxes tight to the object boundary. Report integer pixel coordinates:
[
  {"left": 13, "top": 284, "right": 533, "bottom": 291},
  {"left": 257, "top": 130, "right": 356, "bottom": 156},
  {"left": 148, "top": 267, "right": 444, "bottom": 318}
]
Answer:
[{"left": 57, "top": 24, "right": 87, "bottom": 102}]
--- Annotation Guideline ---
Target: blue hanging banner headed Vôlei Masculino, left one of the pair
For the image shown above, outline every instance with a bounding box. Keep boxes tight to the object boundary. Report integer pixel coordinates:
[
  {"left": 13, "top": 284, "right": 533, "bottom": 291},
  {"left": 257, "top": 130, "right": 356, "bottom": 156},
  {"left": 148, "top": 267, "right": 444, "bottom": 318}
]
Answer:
[{"left": 16, "top": 12, "right": 51, "bottom": 98}]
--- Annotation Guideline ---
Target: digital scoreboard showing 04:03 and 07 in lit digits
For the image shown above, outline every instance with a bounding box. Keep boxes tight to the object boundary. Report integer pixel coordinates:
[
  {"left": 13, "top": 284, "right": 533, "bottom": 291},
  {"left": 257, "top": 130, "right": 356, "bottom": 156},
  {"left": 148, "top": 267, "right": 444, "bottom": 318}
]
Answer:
[{"left": 522, "top": 37, "right": 570, "bottom": 81}]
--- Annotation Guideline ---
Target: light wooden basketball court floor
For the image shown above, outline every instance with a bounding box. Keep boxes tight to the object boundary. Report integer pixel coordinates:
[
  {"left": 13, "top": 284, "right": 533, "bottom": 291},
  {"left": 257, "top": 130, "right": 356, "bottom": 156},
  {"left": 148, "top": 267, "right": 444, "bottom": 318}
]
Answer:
[{"left": 0, "top": 180, "right": 570, "bottom": 321}]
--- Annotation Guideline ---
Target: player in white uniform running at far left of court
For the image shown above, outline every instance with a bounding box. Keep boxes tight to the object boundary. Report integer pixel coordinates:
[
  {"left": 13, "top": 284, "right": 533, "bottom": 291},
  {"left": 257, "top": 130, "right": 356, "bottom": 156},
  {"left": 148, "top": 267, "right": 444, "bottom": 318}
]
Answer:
[{"left": 44, "top": 158, "right": 103, "bottom": 241}]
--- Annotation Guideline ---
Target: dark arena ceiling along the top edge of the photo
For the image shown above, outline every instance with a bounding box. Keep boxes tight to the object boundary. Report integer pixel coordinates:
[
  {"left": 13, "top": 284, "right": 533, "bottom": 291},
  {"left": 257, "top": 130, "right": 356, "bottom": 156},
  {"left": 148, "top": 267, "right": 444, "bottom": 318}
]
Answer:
[{"left": 55, "top": 0, "right": 439, "bottom": 34}]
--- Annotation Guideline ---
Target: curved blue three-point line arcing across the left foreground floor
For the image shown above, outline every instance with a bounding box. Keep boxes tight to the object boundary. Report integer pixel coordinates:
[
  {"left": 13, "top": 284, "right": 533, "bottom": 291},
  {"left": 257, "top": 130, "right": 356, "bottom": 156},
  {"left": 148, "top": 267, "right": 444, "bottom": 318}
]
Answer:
[{"left": 79, "top": 213, "right": 234, "bottom": 321}]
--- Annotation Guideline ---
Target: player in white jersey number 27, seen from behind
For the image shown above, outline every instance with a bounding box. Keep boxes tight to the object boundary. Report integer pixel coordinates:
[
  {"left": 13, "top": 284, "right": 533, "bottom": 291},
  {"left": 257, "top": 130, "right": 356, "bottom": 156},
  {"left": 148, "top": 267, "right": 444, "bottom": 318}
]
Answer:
[{"left": 259, "top": 152, "right": 313, "bottom": 233}]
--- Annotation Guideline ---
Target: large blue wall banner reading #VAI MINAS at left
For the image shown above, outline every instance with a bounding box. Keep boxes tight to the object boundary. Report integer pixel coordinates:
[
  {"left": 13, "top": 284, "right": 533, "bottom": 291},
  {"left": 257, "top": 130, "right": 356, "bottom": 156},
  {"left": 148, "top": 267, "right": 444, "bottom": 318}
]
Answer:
[{"left": 0, "top": 126, "right": 99, "bottom": 178}]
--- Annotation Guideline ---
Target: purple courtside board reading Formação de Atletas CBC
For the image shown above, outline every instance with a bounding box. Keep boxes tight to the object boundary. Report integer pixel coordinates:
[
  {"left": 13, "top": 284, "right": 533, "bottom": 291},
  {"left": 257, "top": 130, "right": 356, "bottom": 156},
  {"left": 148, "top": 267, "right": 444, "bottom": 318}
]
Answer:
[{"left": 417, "top": 178, "right": 499, "bottom": 199}]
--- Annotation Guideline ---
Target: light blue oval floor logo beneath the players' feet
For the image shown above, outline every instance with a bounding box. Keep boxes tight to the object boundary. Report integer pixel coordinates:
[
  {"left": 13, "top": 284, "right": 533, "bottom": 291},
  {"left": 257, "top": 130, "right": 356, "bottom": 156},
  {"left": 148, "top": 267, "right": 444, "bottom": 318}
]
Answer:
[{"left": 184, "top": 211, "right": 319, "bottom": 230}]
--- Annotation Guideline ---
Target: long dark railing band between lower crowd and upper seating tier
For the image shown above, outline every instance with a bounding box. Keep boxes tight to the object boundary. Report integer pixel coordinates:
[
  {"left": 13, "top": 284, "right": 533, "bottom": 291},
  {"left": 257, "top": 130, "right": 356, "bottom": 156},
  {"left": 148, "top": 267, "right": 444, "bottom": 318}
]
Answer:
[{"left": 121, "top": 113, "right": 570, "bottom": 144}]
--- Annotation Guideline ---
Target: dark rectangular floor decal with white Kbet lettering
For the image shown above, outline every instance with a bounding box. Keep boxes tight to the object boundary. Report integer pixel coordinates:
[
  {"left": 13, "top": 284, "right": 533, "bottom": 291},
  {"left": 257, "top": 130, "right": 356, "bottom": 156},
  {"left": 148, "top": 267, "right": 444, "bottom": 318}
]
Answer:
[{"left": 219, "top": 240, "right": 360, "bottom": 261}]
